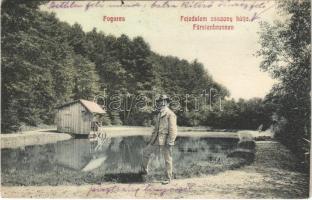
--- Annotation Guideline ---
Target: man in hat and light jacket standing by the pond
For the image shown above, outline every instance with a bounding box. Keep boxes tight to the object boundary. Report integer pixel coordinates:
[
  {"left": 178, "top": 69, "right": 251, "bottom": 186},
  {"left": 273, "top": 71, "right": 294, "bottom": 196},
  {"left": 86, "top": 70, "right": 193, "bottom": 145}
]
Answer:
[{"left": 142, "top": 95, "right": 177, "bottom": 184}]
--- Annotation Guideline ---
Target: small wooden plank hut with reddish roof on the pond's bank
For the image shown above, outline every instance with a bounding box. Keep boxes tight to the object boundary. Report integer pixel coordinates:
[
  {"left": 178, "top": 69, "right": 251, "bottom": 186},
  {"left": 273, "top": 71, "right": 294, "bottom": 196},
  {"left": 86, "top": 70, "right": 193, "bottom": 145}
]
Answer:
[{"left": 56, "top": 99, "right": 105, "bottom": 135}]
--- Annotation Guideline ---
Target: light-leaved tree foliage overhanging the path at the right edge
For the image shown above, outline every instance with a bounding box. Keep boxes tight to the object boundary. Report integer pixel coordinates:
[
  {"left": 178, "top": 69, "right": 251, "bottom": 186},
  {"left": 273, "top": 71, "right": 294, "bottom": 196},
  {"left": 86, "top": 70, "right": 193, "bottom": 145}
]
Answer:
[{"left": 258, "top": 0, "right": 311, "bottom": 153}]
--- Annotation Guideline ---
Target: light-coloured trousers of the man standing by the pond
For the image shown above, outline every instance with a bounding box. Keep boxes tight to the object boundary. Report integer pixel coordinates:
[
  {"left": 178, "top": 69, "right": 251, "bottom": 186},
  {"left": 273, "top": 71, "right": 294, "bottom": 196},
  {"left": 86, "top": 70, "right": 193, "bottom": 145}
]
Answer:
[{"left": 143, "top": 145, "right": 172, "bottom": 180}]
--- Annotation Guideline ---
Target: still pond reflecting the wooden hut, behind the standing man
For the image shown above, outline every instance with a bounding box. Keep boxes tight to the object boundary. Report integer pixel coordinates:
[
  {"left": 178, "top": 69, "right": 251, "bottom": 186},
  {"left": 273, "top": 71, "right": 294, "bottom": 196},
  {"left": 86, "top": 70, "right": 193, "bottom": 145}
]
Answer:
[{"left": 1, "top": 136, "right": 254, "bottom": 186}]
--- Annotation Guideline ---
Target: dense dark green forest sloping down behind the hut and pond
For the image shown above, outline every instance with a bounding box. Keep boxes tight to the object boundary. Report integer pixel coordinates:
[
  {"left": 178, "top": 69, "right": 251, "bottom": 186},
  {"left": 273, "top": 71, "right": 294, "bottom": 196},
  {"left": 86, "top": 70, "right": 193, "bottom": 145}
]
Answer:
[{"left": 1, "top": 0, "right": 270, "bottom": 132}]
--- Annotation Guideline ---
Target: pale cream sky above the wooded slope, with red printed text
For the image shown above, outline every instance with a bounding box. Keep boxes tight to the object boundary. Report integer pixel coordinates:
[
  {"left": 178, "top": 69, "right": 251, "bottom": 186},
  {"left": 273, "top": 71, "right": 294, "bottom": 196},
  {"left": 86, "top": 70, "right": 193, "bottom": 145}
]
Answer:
[{"left": 41, "top": 0, "right": 279, "bottom": 99}]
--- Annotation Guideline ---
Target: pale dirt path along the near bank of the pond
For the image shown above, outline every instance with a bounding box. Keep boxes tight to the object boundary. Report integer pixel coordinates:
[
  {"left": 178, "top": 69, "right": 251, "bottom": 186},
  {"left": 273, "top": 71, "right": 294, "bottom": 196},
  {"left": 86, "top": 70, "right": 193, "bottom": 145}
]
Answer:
[{"left": 1, "top": 141, "right": 309, "bottom": 198}]
